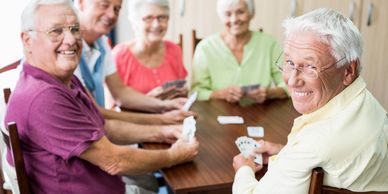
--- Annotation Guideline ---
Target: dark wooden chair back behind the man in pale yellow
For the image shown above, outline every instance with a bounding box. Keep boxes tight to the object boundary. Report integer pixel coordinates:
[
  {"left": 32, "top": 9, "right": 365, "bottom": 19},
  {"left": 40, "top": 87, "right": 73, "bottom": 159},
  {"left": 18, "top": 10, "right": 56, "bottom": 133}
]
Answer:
[{"left": 309, "top": 167, "right": 388, "bottom": 194}]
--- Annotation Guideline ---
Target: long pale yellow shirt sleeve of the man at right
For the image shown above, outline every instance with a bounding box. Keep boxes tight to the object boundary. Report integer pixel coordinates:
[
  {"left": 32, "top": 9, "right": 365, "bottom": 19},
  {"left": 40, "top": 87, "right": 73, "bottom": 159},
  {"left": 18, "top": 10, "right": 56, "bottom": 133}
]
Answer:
[{"left": 233, "top": 142, "right": 323, "bottom": 194}]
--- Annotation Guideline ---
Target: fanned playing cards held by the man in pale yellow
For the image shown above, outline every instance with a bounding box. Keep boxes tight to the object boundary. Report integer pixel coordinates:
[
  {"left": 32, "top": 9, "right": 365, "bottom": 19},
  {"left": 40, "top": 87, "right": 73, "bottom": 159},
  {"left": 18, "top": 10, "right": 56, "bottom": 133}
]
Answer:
[{"left": 235, "top": 136, "right": 263, "bottom": 165}]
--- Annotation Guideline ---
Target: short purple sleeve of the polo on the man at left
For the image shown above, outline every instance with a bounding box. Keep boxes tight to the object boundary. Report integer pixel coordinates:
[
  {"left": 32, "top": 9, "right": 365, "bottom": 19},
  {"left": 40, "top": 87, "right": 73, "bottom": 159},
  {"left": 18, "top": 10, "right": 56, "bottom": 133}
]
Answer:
[{"left": 28, "top": 88, "right": 104, "bottom": 160}]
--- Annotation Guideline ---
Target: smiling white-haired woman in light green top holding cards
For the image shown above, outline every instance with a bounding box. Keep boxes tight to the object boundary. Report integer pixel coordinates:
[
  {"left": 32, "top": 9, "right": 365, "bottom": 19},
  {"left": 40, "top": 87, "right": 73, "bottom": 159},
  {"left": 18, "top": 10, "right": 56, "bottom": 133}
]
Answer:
[{"left": 192, "top": 0, "right": 287, "bottom": 103}]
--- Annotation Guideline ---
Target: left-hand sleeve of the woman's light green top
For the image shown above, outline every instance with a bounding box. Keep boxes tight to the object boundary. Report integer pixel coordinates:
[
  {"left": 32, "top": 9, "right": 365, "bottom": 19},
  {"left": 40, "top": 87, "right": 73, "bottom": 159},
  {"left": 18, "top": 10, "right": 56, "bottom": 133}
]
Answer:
[{"left": 191, "top": 42, "right": 212, "bottom": 100}]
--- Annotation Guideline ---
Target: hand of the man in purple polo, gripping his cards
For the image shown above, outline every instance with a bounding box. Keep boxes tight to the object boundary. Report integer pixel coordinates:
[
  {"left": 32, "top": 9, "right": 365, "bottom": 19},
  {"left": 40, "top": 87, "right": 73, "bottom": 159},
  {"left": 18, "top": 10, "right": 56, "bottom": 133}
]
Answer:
[{"left": 168, "top": 137, "right": 199, "bottom": 165}]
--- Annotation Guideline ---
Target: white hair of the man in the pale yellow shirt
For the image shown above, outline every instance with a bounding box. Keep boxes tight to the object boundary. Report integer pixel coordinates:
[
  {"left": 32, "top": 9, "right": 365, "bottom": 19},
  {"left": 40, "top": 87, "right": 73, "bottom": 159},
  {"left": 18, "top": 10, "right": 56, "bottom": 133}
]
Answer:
[{"left": 283, "top": 8, "right": 362, "bottom": 71}]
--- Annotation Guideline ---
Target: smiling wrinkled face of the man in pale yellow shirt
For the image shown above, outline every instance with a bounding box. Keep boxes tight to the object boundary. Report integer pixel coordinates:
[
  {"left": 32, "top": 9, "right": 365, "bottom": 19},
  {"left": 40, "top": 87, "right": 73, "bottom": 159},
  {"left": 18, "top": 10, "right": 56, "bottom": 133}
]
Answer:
[{"left": 283, "top": 32, "right": 346, "bottom": 114}]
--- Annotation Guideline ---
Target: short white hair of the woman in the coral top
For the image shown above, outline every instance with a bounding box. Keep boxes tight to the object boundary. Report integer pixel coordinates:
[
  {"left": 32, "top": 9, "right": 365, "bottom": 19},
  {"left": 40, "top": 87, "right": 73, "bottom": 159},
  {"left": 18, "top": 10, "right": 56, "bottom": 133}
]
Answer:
[{"left": 128, "top": 0, "right": 170, "bottom": 21}]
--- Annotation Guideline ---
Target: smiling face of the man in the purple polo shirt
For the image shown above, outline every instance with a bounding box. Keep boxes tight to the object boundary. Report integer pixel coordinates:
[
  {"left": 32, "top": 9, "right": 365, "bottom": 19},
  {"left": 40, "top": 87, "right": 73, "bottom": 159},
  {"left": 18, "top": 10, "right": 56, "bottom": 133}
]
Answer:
[{"left": 22, "top": 5, "right": 82, "bottom": 79}]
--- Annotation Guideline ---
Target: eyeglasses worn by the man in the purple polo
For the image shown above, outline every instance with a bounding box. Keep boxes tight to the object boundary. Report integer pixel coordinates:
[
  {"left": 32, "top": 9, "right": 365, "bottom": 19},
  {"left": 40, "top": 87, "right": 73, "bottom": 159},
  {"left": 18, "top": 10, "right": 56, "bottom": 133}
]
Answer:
[{"left": 30, "top": 25, "right": 82, "bottom": 42}]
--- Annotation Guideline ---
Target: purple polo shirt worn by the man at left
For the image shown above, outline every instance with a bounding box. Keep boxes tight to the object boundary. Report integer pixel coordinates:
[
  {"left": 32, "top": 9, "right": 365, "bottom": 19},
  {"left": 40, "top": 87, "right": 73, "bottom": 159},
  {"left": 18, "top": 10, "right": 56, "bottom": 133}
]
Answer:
[{"left": 5, "top": 64, "right": 125, "bottom": 194}]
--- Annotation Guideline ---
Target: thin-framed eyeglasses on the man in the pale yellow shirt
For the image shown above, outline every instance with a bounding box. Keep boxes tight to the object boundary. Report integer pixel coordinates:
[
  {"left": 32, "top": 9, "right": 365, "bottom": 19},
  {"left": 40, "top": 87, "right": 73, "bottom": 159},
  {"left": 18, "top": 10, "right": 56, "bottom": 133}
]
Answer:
[{"left": 275, "top": 52, "right": 345, "bottom": 79}]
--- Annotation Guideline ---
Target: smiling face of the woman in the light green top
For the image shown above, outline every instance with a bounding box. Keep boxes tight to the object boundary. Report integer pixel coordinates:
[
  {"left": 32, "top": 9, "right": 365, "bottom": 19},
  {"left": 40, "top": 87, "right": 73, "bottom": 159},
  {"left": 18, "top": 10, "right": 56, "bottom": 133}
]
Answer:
[{"left": 221, "top": 0, "right": 252, "bottom": 36}]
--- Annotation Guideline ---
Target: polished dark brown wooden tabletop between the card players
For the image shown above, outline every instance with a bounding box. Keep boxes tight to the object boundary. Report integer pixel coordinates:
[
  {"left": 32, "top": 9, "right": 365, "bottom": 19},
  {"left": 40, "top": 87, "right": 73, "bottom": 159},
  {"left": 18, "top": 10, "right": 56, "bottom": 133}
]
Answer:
[{"left": 145, "top": 99, "right": 299, "bottom": 193}]
